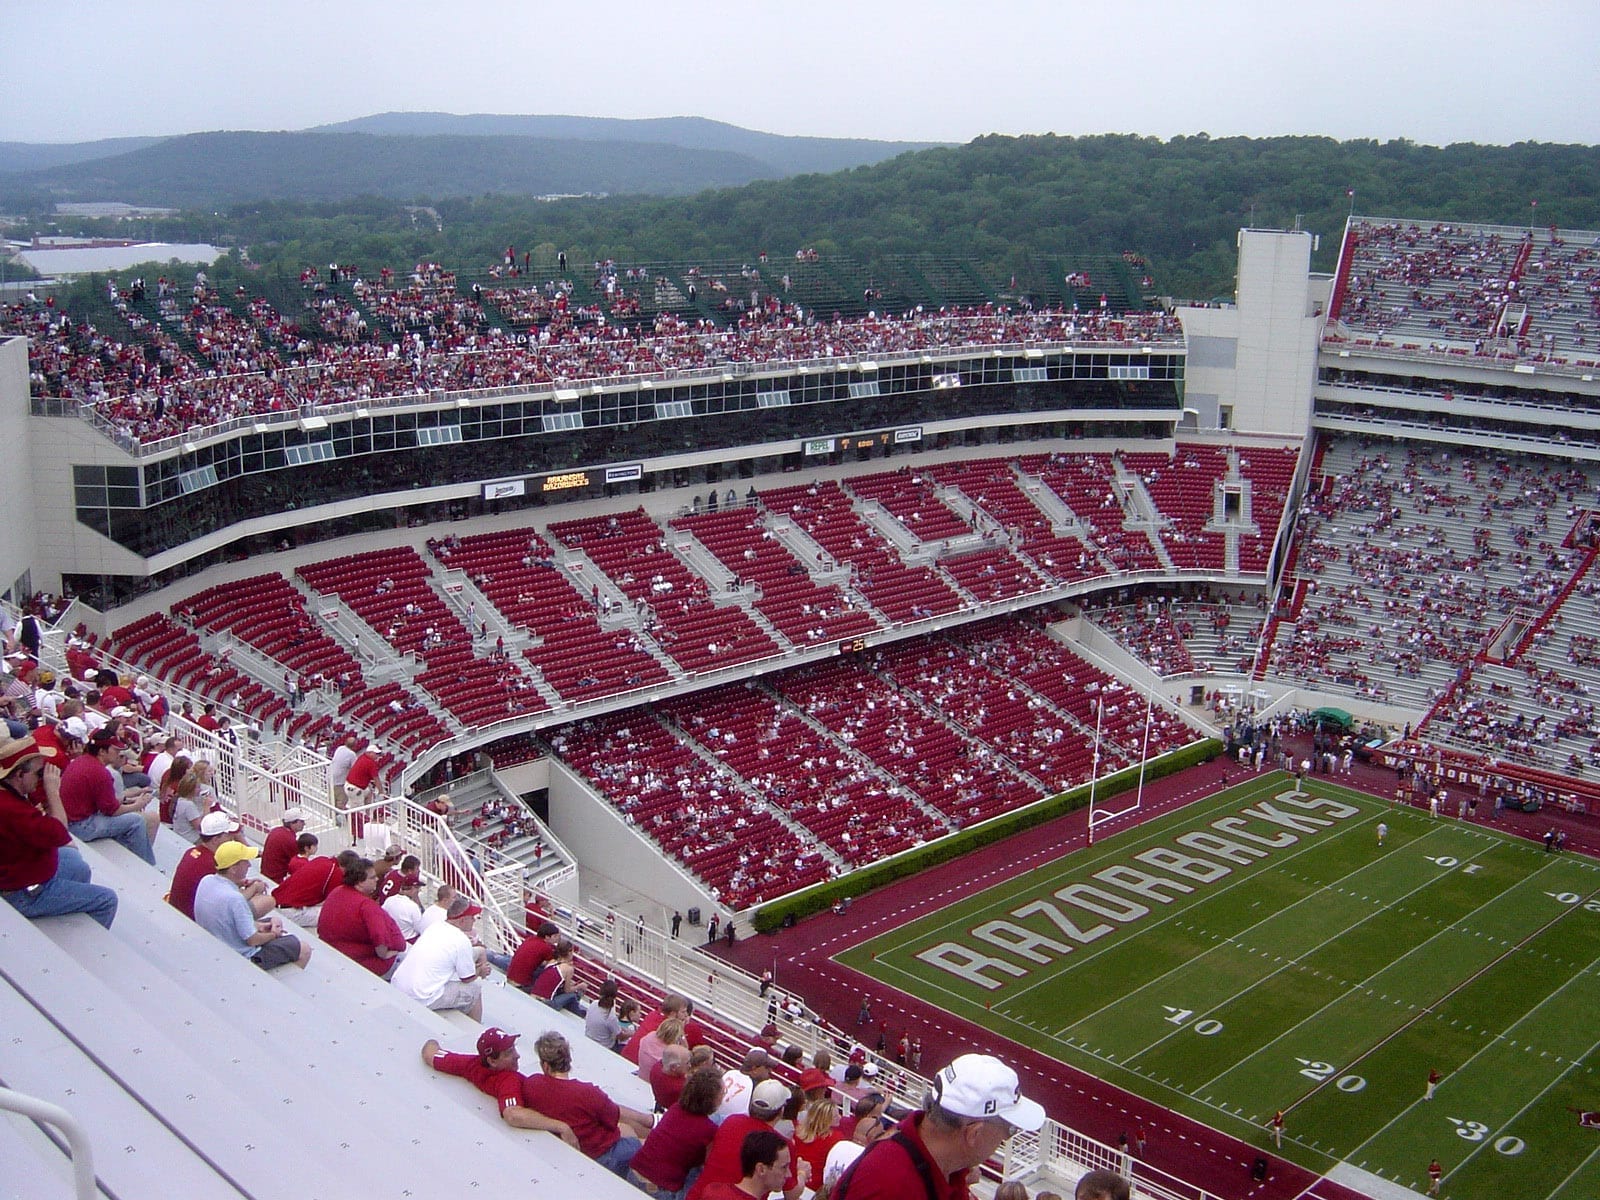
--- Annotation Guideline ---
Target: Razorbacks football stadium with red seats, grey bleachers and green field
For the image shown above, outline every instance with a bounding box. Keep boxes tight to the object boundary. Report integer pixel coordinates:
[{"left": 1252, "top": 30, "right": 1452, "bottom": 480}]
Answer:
[{"left": 0, "top": 214, "right": 1600, "bottom": 1200}]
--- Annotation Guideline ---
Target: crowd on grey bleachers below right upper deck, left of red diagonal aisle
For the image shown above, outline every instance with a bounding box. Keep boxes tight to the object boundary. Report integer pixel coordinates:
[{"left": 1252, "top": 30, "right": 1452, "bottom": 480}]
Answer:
[{"left": 1270, "top": 438, "right": 1600, "bottom": 706}]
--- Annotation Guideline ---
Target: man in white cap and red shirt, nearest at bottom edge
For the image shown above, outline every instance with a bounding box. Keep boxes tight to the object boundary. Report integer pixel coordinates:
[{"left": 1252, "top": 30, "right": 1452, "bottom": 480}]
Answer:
[{"left": 834, "top": 1054, "right": 1045, "bottom": 1200}]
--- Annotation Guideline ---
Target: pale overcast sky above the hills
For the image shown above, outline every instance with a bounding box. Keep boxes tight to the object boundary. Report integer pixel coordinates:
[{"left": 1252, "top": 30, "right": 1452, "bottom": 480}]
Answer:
[{"left": 12, "top": 0, "right": 1600, "bottom": 144}]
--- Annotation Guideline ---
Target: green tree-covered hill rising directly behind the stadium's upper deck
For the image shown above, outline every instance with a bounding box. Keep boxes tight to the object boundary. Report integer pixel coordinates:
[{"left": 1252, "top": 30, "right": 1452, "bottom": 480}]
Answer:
[{"left": 25, "top": 134, "right": 1600, "bottom": 298}]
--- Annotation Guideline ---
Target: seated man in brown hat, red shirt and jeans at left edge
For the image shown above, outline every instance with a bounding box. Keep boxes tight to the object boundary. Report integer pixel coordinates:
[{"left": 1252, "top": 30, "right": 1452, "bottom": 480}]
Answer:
[{"left": 0, "top": 738, "right": 117, "bottom": 930}]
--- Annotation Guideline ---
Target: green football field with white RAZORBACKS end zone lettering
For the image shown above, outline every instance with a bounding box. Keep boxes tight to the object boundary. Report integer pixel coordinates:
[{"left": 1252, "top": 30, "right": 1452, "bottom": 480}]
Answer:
[{"left": 840, "top": 774, "right": 1600, "bottom": 1200}]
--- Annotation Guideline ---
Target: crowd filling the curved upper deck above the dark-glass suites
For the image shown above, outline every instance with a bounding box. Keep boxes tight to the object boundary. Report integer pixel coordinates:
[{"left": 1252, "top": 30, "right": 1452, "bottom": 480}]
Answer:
[{"left": 0, "top": 262, "right": 1181, "bottom": 442}]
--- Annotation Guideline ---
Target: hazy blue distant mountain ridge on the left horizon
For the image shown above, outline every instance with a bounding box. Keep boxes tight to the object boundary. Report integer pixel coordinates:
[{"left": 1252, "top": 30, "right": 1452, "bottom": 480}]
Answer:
[{"left": 0, "top": 112, "right": 923, "bottom": 208}]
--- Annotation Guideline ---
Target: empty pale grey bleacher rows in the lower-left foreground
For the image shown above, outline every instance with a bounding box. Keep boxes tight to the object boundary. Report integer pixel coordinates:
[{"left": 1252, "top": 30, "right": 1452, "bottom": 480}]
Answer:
[{"left": 0, "top": 837, "right": 648, "bottom": 1197}]
